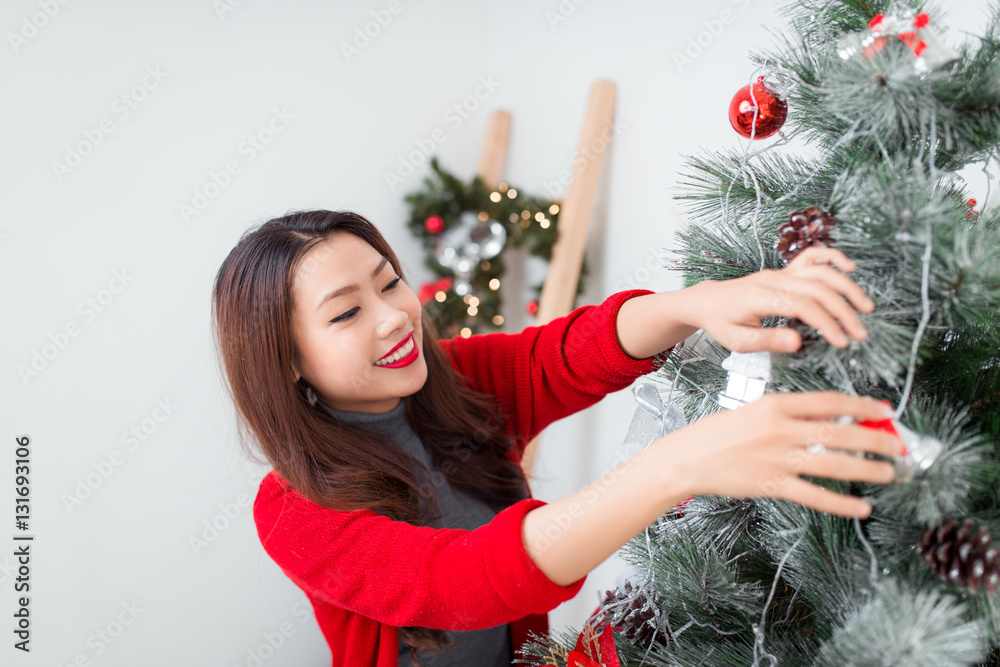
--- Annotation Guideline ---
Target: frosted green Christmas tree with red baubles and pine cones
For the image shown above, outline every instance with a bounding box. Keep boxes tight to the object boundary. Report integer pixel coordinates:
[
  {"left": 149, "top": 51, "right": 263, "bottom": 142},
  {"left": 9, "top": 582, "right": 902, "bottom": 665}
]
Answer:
[{"left": 522, "top": 0, "right": 1000, "bottom": 667}]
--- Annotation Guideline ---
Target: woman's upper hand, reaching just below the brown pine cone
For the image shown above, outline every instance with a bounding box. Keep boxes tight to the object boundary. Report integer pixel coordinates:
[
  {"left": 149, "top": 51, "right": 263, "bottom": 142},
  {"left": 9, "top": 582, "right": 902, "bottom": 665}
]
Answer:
[{"left": 684, "top": 248, "right": 875, "bottom": 352}]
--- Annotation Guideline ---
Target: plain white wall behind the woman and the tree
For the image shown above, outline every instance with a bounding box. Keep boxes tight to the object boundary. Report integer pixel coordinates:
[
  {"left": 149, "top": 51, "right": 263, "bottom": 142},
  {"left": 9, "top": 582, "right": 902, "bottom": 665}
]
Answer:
[{"left": 0, "top": 0, "right": 985, "bottom": 666}]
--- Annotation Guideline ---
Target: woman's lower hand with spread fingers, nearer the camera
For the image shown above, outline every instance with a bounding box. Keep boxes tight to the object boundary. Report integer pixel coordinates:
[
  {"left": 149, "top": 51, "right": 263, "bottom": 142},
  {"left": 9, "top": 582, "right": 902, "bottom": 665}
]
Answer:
[{"left": 647, "top": 392, "right": 902, "bottom": 518}]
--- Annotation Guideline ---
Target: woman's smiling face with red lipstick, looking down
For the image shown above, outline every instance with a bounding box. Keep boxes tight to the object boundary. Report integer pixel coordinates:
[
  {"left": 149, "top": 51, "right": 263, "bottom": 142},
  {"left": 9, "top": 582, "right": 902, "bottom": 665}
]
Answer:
[{"left": 292, "top": 231, "right": 427, "bottom": 413}]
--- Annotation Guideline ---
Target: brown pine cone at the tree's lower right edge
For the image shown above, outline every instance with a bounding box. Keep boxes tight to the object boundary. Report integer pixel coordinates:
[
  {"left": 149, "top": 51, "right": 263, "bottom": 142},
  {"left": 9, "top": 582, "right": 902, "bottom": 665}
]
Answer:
[{"left": 919, "top": 517, "right": 1000, "bottom": 593}]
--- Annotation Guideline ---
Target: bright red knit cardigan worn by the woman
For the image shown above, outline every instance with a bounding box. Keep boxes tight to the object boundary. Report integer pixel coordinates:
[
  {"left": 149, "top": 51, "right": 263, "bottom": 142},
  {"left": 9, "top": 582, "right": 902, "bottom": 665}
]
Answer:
[{"left": 254, "top": 290, "right": 655, "bottom": 667}]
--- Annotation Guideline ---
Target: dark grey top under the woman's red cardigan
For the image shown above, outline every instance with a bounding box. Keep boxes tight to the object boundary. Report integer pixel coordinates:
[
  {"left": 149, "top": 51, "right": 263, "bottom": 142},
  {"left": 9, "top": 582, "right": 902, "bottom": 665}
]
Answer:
[{"left": 318, "top": 401, "right": 514, "bottom": 667}]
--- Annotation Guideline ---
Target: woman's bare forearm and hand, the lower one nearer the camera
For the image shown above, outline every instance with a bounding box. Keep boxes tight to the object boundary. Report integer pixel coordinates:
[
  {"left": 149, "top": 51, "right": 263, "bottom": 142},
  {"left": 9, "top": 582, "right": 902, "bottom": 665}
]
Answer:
[{"left": 522, "top": 392, "right": 901, "bottom": 585}]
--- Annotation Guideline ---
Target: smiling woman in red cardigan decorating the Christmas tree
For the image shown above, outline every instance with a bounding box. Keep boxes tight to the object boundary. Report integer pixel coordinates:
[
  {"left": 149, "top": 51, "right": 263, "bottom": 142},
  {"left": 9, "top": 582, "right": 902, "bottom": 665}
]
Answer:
[{"left": 213, "top": 211, "right": 901, "bottom": 667}]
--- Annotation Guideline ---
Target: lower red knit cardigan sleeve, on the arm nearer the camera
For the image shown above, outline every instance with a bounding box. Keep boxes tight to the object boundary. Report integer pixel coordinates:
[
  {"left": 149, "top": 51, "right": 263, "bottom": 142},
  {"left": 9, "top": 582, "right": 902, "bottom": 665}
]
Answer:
[{"left": 254, "top": 471, "right": 586, "bottom": 630}]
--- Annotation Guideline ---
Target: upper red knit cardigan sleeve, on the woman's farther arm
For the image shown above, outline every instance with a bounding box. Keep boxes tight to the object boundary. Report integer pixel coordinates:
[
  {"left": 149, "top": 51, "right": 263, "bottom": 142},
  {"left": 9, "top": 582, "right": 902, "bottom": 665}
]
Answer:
[{"left": 439, "top": 289, "right": 656, "bottom": 458}]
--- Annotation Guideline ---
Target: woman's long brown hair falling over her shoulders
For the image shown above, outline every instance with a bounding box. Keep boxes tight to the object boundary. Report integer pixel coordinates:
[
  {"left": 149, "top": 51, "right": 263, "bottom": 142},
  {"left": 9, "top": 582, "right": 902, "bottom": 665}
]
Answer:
[{"left": 212, "top": 210, "right": 527, "bottom": 665}]
